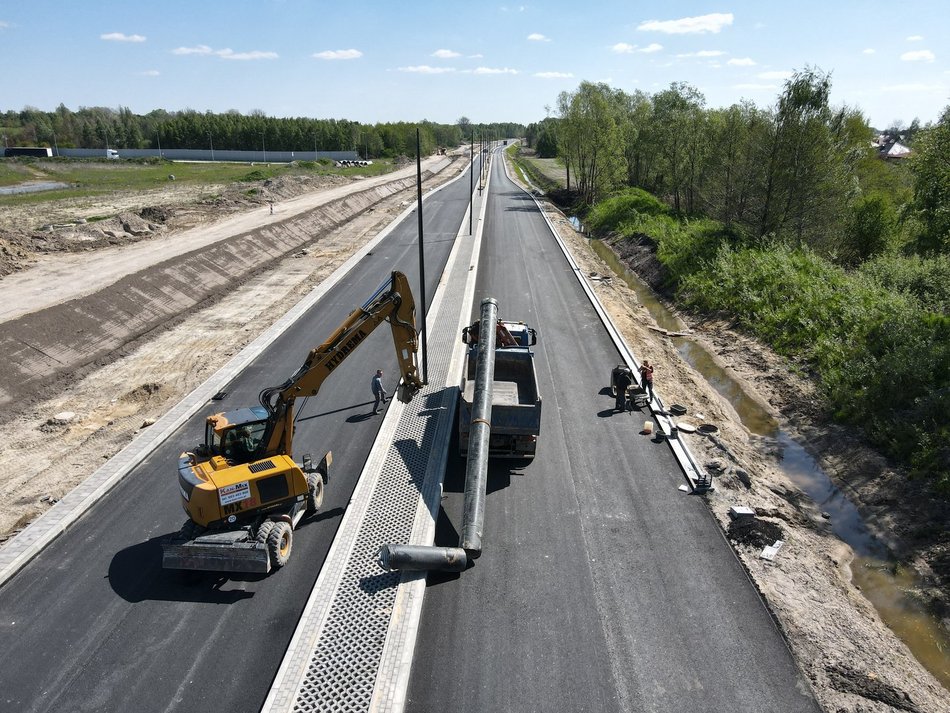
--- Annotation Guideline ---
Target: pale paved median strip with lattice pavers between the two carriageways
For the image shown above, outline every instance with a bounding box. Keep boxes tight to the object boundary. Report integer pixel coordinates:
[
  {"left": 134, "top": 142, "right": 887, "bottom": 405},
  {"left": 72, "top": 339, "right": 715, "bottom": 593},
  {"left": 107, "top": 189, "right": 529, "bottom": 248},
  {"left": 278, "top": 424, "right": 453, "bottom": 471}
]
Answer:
[{"left": 262, "top": 157, "right": 488, "bottom": 713}]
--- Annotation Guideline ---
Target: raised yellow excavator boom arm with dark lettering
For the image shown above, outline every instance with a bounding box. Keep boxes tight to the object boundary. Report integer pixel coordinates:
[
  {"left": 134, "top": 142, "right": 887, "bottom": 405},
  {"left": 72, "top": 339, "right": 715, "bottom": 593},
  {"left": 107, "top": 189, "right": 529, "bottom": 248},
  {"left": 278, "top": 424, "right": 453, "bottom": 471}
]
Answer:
[{"left": 260, "top": 271, "right": 423, "bottom": 455}]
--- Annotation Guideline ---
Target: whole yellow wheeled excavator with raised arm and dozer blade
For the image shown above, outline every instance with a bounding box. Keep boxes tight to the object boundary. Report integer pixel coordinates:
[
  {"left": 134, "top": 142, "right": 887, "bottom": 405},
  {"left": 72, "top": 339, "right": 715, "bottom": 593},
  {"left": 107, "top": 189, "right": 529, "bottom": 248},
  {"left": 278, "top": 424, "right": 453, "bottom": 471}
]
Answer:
[{"left": 162, "top": 272, "right": 423, "bottom": 574}]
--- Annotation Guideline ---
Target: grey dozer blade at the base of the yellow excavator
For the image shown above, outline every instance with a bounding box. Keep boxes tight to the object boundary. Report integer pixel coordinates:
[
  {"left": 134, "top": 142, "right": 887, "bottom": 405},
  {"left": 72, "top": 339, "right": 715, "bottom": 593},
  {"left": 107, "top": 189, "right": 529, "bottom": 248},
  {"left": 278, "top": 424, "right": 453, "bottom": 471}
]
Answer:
[{"left": 162, "top": 533, "right": 271, "bottom": 574}]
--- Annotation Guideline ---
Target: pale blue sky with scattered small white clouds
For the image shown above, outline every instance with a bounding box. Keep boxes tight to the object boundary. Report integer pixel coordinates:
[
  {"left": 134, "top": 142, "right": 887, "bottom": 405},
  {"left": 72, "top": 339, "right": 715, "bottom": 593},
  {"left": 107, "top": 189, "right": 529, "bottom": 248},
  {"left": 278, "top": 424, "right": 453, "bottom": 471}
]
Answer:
[{"left": 0, "top": 0, "right": 950, "bottom": 128}]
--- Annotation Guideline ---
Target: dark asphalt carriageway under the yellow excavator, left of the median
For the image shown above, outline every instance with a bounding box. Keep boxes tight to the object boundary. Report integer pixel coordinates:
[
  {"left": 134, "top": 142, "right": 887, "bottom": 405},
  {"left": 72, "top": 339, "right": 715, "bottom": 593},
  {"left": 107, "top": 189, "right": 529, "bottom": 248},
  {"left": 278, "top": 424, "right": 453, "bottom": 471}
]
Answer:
[{"left": 0, "top": 157, "right": 484, "bottom": 713}]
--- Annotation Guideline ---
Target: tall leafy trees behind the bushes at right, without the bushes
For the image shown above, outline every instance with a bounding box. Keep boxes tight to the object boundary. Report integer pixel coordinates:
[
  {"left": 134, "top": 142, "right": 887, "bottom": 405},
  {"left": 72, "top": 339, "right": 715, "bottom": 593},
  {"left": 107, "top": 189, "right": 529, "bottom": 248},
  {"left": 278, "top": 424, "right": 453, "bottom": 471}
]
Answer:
[{"left": 526, "top": 68, "right": 950, "bottom": 265}]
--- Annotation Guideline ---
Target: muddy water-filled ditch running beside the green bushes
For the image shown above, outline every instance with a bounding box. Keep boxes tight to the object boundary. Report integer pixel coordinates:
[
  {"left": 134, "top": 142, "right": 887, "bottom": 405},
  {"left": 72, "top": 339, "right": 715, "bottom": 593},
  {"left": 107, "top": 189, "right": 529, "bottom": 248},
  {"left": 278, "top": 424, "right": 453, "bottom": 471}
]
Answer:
[{"left": 588, "top": 238, "right": 950, "bottom": 689}]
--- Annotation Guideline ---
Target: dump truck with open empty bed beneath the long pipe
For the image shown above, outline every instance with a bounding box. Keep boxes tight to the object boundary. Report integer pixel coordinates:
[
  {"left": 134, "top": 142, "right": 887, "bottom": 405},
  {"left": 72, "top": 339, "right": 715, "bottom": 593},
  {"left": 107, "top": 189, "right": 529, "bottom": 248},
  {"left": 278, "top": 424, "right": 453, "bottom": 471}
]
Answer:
[{"left": 458, "top": 319, "right": 541, "bottom": 459}]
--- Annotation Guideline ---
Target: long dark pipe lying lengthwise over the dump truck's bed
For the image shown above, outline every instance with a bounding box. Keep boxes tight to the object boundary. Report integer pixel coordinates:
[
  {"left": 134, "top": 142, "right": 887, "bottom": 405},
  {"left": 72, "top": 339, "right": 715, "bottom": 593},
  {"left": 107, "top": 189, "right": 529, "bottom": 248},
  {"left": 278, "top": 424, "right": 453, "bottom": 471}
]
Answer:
[{"left": 459, "top": 297, "right": 498, "bottom": 559}]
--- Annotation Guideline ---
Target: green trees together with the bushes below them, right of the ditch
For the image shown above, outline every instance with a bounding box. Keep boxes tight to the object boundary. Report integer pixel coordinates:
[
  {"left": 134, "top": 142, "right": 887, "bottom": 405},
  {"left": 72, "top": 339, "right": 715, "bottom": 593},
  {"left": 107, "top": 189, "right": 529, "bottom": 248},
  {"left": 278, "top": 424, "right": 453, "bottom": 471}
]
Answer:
[{"left": 526, "top": 73, "right": 950, "bottom": 494}]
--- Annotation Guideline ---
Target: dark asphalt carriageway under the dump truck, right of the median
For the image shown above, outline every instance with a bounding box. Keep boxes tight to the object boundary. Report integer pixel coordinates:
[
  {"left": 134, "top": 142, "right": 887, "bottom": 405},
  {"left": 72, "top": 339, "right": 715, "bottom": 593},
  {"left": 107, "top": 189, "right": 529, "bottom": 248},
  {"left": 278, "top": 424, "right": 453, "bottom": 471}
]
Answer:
[{"left": 407, "top": 156, "right": 818, "bottom": 713}]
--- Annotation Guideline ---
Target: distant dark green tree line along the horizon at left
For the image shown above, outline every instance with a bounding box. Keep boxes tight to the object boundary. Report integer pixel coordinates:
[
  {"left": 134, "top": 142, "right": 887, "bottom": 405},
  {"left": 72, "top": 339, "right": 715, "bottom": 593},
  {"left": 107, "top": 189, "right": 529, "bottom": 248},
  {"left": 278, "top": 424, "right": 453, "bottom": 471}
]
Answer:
[{"left": 0, "top": 104, "right": 524, "bottom": 158}]
